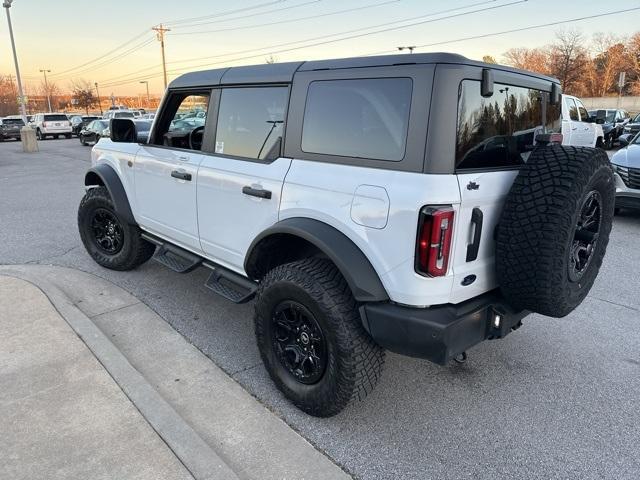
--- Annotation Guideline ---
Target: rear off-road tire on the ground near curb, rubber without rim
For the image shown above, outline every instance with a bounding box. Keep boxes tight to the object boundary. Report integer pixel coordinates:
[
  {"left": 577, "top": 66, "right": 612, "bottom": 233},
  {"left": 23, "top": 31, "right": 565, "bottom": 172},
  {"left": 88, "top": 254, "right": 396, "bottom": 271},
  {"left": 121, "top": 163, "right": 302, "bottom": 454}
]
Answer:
[{"left": 255, "top": 258, "right": 384, "bottom": 417}]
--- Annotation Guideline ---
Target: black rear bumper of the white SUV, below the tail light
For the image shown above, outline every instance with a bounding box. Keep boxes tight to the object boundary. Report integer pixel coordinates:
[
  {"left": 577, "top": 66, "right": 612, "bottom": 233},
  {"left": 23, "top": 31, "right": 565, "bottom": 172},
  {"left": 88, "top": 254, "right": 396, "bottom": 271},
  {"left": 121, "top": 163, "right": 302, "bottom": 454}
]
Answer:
[{"left": 361, "top": 291, "right": 529, "bottom": 365}]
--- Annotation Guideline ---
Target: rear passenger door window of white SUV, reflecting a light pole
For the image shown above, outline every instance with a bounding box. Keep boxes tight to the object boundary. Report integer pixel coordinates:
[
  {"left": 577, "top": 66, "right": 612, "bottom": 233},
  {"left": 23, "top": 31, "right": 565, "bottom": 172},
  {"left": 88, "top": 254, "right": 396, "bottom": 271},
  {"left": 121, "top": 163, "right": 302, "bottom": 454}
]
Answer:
[{"left": 215, "top": 87, "right": 289, "bottom": 160}]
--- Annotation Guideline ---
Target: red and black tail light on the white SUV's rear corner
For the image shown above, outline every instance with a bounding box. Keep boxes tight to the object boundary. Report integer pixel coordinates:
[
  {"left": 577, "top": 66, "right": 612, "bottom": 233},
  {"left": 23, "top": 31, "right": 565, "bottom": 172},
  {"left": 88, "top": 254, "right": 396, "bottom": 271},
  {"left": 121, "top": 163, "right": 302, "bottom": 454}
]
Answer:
[{"left": 415, "top": 207, "right": 453, "bottom": 277}]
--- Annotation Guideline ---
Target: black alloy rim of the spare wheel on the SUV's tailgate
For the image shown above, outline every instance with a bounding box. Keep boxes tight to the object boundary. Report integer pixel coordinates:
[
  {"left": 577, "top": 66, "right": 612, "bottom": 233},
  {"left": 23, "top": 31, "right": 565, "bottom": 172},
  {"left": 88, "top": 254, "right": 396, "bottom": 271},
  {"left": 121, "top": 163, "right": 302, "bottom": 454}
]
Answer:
[{"left": 569, "top": 190, "right": 602, "bottom": 282}]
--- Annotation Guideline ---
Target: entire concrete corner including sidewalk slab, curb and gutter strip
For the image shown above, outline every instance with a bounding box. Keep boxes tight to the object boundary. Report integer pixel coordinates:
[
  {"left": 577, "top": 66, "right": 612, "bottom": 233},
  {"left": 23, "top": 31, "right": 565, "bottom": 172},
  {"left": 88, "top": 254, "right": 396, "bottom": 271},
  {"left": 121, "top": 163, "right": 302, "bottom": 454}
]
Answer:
[{"left": 0, "top": 266, "right": 349, "bottom": 480}]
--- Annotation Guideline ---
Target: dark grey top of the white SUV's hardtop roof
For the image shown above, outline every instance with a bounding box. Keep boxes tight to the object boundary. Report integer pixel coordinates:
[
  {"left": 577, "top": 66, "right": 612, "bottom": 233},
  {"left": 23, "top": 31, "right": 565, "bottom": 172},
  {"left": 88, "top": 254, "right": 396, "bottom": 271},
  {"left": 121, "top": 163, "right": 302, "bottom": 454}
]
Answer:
[{"left": 169, "top": 52, "right": 559, "bottom": 88}]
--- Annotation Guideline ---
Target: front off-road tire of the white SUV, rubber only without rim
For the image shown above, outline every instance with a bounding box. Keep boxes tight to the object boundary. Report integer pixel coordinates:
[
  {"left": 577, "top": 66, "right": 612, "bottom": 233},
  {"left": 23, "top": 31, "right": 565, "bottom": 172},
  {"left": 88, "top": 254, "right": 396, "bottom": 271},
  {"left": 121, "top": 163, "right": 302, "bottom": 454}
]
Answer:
[{"left": 78, "top": 187, "right": 155, "bottom": 270}]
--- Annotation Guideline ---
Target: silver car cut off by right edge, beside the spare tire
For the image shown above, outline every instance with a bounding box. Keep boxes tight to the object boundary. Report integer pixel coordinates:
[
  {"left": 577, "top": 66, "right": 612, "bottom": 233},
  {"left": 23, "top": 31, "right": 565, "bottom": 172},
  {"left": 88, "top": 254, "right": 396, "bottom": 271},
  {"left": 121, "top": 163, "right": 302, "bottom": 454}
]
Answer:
[{"left": 611, "top": 133, "right": 640, "bottom": 210}]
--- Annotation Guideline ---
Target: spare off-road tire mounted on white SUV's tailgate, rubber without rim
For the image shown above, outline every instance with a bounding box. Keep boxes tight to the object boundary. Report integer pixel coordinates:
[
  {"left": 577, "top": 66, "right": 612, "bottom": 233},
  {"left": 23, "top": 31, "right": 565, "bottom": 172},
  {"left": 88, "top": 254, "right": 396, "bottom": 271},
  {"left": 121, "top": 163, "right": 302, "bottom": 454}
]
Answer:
[{"left": 496, "top": 145, "right": 615, "bottom": 317}]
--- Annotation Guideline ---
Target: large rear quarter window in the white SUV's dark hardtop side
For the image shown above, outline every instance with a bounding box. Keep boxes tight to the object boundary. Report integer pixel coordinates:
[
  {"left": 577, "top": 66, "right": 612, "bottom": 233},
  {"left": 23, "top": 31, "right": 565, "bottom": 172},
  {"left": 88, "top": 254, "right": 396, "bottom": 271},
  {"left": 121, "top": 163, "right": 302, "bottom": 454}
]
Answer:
[{"left": 302, "top": 78, "right": 412, "bottom": 161}]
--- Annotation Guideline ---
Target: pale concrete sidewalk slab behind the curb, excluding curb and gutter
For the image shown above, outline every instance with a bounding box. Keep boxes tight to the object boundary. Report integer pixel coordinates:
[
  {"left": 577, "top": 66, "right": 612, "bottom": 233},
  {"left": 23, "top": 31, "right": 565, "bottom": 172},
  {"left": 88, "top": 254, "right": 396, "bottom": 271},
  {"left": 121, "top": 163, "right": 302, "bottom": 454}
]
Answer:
[{"left": 0, "top": 276, "right": 192, "bottom": 479}]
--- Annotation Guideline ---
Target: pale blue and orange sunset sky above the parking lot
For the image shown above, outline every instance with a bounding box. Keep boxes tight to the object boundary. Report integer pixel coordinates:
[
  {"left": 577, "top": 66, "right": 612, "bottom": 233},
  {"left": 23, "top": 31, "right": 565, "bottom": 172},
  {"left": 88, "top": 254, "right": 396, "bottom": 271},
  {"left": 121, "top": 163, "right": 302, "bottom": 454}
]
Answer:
[{"left": 0, "top": 0, "right": 640, "bottom": 95}]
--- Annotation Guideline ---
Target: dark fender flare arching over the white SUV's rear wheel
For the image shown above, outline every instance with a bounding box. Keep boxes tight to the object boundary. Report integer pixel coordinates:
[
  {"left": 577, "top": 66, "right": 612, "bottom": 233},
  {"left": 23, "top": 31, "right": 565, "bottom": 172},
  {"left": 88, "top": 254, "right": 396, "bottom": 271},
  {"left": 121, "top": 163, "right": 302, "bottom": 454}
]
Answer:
[{"left": 244, "top": 217, "right": 389, "bottom": 302}]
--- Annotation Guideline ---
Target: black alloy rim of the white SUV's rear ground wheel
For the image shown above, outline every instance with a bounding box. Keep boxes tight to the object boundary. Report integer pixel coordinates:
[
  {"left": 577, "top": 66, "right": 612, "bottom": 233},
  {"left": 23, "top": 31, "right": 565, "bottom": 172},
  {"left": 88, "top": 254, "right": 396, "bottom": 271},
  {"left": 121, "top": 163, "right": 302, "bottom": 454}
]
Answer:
[{"left": 271, "top": 300, "right": 327, "bottom": 385}]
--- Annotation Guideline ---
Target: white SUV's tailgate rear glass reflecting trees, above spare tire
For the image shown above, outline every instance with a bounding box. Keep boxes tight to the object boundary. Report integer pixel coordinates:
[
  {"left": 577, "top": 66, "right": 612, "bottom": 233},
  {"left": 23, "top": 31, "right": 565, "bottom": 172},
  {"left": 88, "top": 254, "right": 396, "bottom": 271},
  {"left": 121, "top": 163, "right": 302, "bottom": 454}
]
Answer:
[{"left": 456, "top": 80, "right": 561, "bottom": 169}]
